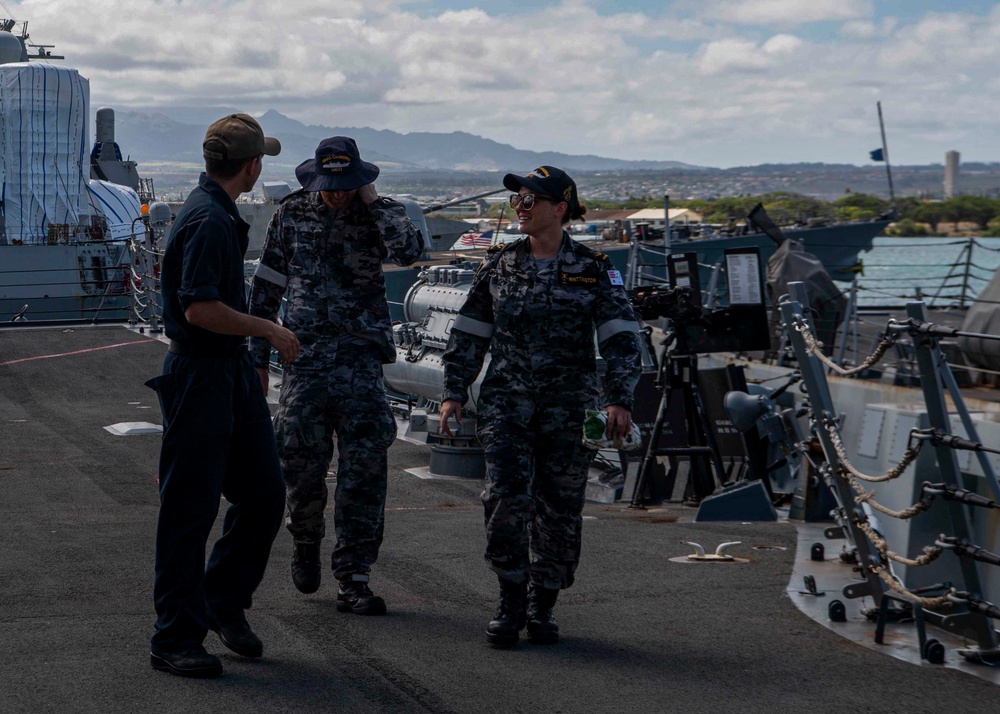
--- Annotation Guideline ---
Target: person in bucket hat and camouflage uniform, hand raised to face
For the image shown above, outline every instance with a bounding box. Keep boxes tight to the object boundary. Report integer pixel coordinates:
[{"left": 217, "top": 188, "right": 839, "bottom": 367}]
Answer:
[{"left": 250, "top": 137, "right": 422, "bottom": 615}]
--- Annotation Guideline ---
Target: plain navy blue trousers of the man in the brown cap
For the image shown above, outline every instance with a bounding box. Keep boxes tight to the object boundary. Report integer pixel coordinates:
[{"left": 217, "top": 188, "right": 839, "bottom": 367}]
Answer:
[{"left": 147, "top": 353, "right": 285, "bottom": 652}]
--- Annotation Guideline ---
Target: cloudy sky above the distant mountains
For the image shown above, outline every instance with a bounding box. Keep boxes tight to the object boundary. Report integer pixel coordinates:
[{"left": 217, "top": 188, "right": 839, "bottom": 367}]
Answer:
[{"left": 13, "top": 0, "right": 1000, "bottom": 167}]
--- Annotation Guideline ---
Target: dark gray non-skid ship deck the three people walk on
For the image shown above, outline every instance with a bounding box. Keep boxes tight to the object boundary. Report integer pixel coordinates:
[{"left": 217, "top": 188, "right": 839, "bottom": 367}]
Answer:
[{"left": 0, "top": 326, "right": 1000, "bottom": 714}]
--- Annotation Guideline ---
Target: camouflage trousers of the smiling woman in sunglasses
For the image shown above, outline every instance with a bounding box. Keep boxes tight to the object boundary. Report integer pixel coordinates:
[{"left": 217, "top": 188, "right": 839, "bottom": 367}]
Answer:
[{"left": 477, "top": 392, "right": 596, "bottom": 590}]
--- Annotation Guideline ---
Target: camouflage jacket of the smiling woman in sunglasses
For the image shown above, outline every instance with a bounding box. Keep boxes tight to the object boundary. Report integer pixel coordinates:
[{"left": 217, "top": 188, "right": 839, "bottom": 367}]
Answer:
[{"left": 443, "top": 233, "right": 641, "bottom": 409}]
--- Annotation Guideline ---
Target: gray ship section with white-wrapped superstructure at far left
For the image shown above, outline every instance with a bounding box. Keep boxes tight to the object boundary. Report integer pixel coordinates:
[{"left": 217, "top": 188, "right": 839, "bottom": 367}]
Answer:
[{"left": 0, "top": 20, "right": 146, "bottom": 321}]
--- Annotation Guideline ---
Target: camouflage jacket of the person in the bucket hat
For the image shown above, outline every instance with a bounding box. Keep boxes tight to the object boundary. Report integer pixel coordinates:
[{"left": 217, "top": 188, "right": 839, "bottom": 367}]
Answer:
[{"left": 250, "top": 191, "right": 423, "bottom": 369}]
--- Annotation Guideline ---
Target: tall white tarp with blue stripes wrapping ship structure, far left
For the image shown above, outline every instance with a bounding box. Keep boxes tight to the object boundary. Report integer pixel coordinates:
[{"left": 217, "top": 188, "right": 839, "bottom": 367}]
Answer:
[{"left": 0, "top": 63, "right": 93, "bottom": 244}]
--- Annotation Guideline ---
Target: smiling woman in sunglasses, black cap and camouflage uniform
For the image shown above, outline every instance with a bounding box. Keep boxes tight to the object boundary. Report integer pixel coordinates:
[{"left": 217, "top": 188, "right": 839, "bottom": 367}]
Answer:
[{"left": 441, "top": 166, "right": 640, "bottom": 647}]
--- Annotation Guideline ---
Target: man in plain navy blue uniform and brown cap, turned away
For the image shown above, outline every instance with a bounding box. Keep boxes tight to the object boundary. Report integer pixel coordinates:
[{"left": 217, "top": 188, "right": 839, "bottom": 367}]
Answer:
[{"left": 147, "top": 114, "right": 299, "bottom": 677}]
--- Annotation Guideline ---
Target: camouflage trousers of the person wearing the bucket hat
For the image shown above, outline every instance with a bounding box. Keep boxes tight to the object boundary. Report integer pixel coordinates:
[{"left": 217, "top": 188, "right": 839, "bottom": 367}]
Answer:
[{"left": 275, "top": 346, "right": 396, "bottom": 580}]
